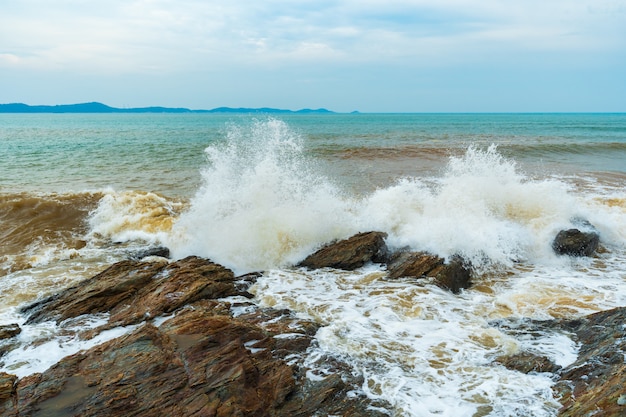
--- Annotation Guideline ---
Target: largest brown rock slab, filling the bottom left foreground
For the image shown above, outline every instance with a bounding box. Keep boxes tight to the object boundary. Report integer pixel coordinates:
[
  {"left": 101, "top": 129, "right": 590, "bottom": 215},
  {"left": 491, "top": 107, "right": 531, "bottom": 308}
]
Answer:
[{"left": 0, "top": 300, "right": 386, "bottom": 417}]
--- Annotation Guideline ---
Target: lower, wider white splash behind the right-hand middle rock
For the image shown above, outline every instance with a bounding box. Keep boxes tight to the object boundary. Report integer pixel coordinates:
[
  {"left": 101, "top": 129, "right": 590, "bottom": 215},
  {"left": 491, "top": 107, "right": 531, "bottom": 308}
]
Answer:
[{"left": 362, "top": 145, "right": 581, "bottom": 268}]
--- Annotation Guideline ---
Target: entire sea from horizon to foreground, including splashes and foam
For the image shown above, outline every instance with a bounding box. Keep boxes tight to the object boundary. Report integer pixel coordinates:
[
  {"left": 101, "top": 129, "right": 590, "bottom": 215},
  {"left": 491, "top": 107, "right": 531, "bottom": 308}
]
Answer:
[{"left": 0, "top": 113, "right": 626, "bottom": 417}]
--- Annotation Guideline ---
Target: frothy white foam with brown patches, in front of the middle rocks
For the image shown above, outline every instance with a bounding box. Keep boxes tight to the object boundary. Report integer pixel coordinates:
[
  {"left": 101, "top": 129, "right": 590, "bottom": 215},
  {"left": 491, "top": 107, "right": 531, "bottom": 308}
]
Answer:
[{"left": 252, "top": 269, "right": 570, "bottom": 416}]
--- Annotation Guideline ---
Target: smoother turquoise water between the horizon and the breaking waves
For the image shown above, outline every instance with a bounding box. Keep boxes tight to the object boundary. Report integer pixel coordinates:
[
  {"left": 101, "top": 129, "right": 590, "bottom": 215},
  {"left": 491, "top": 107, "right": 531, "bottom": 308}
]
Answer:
[{"left": 0, "top": 114, "right": 626, "bottom": 196}]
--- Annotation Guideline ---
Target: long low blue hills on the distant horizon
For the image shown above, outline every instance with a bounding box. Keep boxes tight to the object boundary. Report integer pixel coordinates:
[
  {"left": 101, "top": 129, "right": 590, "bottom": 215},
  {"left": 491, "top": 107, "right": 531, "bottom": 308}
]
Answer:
[{"left": 0, "top": 102, "right": 334, "bottom": 114}]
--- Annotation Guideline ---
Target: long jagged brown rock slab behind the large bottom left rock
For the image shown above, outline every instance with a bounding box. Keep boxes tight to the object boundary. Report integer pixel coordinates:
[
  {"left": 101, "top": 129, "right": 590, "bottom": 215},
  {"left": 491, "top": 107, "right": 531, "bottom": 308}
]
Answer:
[{"left": 23, "top": 256, "right": 241, "bottom": 327}]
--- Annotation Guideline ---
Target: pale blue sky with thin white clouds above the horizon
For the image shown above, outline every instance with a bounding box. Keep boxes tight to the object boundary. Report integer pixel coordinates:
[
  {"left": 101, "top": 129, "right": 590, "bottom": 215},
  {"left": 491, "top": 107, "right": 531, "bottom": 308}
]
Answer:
[{"left": 0, "top": 0, "right": 626, "bottom": 112}]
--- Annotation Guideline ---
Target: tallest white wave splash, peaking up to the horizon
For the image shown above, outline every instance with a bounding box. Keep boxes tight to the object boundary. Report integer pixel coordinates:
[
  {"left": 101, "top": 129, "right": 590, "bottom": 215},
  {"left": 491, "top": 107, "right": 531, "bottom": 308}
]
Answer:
[{"left": 168, "top": 119, "right": 355, "bottom": 272}]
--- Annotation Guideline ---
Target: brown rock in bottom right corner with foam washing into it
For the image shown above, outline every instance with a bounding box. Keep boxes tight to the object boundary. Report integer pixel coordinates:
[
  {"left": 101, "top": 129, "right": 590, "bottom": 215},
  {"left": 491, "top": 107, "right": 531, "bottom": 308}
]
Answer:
[{"left": 492, "top": 307, "right": 626, "bottom": 417}]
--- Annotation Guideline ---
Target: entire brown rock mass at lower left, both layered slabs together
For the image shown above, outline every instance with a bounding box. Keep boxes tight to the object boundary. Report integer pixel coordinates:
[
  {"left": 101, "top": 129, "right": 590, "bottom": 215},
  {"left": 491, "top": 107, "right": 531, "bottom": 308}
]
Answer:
[{"left": 0, "top": 257, "right": 389, "bottom": 417}]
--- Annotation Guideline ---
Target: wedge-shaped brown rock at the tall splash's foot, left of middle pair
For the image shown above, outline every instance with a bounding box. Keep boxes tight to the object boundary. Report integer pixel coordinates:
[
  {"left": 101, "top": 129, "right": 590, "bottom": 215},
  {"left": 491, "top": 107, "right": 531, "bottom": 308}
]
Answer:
[{"left": 298, "top": 232, "right": 387, "bottom": 271}]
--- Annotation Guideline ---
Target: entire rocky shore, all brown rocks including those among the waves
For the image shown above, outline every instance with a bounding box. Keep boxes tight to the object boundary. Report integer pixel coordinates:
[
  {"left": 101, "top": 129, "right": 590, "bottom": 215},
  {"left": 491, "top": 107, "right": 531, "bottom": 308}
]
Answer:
[{"left": 0, "top": 231, "right": 626, "bottom": 417}]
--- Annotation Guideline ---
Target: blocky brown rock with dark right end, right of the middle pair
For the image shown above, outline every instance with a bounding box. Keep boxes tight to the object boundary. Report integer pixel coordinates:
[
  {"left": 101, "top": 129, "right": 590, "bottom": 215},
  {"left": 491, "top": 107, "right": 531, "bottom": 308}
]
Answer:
[{"left": 387, "top": 252, "right": 471, "bottom": 294}]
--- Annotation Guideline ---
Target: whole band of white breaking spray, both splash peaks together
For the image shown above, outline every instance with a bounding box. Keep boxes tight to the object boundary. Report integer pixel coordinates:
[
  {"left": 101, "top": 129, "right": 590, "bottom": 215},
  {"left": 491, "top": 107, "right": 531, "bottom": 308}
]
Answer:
[{"left": 165, "top": 119, "right": 626, "bottom": 272}]
